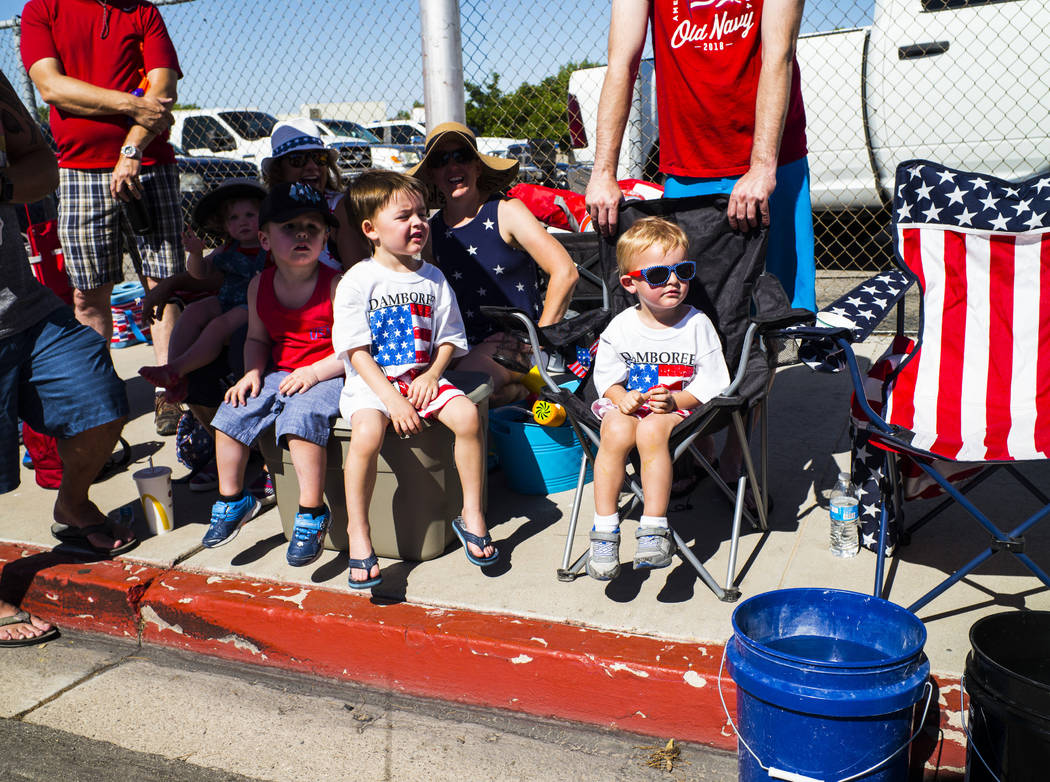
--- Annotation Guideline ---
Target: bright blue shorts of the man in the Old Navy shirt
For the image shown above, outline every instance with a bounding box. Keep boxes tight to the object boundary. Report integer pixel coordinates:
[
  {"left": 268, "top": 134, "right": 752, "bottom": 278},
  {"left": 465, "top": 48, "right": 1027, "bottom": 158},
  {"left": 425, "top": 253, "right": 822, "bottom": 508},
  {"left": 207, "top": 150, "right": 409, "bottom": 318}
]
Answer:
[{"left": 664, "top": 157, "right": 817, "bottom": 312}]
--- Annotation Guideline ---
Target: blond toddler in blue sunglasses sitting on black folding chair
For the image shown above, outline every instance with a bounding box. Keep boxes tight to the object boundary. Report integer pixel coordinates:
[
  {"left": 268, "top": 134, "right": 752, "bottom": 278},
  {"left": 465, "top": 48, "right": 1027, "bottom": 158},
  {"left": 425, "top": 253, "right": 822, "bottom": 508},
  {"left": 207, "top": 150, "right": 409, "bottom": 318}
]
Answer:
[{"left": 587, "top": 217, "right": 730, "bottom": 580}]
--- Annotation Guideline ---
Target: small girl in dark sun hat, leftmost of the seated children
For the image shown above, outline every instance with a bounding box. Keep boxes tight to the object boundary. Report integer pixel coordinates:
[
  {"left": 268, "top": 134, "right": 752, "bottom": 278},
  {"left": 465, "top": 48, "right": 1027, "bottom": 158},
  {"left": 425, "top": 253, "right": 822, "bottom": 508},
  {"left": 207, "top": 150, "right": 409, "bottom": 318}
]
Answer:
[{"left": 139, "top": 179, "right": 268, "bottom": 402}]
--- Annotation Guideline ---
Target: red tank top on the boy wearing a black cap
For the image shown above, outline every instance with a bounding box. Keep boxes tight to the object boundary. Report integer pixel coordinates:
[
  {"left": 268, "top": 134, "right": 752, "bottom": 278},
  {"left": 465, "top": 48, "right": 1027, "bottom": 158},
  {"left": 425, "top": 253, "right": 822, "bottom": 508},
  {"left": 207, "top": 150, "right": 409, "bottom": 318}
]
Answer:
[{"left": 255, "top": 263, "right": 339, "bottom": 372}]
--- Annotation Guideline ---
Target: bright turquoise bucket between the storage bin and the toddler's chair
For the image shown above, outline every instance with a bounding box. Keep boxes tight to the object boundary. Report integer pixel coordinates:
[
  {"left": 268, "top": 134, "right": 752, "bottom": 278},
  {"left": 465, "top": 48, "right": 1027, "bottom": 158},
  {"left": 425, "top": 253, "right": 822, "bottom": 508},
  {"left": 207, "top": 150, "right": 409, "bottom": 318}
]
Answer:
[{"left": 488, "top": 405, "right": 592, "bottom": 494}]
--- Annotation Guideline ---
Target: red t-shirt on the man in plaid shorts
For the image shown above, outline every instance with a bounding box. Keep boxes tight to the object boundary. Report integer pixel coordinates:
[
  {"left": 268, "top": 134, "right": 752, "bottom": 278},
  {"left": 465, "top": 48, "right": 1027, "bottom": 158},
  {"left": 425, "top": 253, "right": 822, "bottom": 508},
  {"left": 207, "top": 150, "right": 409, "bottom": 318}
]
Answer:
[{"left": 22, "top": 0, "right": 183, "bottom": 168}]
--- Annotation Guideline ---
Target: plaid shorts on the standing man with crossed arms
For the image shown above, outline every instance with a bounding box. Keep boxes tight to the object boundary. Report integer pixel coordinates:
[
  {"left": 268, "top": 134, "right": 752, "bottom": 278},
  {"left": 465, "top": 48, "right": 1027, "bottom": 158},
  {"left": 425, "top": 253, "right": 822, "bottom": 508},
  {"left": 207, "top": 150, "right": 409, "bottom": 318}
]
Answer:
[{"left": 59, "top": 165, "right": 186, "bottom": 291}]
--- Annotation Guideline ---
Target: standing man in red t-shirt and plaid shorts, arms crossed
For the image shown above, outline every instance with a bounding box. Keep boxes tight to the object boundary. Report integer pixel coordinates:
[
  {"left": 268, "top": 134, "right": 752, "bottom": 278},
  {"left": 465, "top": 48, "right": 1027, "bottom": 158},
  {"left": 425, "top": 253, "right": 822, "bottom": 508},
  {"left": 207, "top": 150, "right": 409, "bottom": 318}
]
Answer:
[{"left": 22, "top": 0, "right": 185, "bottom": 435}]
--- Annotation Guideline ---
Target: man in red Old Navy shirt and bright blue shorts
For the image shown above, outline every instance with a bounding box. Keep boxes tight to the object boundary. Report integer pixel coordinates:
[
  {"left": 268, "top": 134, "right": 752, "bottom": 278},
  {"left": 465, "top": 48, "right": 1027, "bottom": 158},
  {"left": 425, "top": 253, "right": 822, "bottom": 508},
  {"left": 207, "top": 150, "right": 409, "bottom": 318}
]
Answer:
[{"left": 587, "top": 0, "right": 816, "bottom": 310}]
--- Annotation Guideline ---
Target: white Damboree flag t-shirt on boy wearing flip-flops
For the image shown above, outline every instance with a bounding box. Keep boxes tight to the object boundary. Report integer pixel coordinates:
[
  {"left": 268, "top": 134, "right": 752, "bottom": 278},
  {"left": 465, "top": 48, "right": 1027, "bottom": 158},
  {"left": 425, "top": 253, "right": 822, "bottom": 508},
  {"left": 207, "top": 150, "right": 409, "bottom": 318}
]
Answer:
[{"left": 332, "top": 258, "right": 467, "bottom": 409}]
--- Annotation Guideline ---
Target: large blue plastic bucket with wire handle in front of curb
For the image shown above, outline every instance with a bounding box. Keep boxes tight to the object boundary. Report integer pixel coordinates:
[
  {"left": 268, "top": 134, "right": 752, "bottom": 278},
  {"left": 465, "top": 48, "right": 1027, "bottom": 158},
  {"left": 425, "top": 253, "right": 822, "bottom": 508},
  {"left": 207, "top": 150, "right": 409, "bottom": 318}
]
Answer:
[{"left": 727, "top": 589, "right": 932, "bottom": 782}]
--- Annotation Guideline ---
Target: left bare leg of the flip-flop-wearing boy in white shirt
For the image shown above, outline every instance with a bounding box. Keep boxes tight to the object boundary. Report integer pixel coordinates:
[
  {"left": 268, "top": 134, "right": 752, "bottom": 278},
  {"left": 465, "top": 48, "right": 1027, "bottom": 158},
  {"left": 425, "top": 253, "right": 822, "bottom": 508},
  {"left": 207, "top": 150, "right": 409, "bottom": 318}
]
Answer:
[{"left": 344, "top": 409, "right": 387, "bottom": 582}]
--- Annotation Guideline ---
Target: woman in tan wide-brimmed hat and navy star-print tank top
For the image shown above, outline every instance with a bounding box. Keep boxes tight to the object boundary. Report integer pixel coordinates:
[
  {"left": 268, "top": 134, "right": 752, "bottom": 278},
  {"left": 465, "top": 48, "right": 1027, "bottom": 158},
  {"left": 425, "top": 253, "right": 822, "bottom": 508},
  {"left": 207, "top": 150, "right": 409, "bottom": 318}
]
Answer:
[{"left": 408, "top": 122, "right": 579, "bottom": 404}]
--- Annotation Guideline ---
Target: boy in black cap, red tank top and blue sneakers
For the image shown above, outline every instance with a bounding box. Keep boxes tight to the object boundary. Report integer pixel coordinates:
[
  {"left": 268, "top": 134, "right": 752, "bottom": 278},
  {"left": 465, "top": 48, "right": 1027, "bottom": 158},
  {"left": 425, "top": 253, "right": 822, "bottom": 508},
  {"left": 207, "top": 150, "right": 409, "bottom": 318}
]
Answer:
[{"left": 203, "top": 183, "right": 342, "bottom": 566}]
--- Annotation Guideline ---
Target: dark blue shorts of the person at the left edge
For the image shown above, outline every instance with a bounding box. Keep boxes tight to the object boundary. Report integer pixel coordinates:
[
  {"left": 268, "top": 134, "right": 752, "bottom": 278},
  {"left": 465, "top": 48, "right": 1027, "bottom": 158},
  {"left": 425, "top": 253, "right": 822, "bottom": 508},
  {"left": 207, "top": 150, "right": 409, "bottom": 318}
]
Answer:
[{"left": 0, "top": 307, "right": 128, "bottom": 493}]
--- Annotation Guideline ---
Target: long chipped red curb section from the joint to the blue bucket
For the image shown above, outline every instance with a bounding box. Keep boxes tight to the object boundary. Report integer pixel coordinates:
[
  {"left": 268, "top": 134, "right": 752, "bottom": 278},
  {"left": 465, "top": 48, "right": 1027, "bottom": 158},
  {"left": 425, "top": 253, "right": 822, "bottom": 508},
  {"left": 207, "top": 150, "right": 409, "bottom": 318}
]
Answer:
[{"left": 142, "top": 572, "right": 736, "bottom": 749}]
